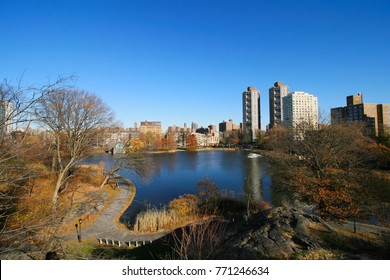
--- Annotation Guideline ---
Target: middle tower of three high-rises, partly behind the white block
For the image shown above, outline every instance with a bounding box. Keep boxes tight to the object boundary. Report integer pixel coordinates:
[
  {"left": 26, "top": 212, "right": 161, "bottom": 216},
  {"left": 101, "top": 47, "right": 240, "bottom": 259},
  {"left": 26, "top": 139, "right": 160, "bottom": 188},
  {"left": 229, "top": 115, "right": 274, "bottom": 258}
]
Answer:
[{"left": 269, "top": 82, "right": 288, "bottom": 128}]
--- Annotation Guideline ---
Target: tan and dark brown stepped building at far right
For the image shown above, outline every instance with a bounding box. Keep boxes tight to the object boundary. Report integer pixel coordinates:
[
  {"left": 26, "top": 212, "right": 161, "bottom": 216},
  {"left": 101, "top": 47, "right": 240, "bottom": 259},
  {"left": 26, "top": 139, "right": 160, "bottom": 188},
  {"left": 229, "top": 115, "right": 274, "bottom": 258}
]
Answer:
[{"left": 330, "top": 92, "right": 390, "bottom": 136}]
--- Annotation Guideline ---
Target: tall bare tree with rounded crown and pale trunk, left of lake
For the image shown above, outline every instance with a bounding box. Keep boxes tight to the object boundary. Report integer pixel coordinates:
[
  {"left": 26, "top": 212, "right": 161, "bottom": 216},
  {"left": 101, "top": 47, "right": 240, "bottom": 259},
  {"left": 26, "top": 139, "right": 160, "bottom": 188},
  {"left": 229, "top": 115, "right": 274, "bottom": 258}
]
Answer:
[{"left": 35, "top": 89, "right": 113, "bottom": 206}]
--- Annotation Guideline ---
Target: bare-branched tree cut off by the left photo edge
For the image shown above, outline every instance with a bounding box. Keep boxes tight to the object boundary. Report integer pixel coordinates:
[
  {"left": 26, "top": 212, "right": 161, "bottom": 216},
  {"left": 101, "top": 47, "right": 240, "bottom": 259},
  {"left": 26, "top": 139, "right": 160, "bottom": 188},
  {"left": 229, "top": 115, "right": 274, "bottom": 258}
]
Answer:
[{"left": 0, "top": 77, "right": 71, "bottom": 254}]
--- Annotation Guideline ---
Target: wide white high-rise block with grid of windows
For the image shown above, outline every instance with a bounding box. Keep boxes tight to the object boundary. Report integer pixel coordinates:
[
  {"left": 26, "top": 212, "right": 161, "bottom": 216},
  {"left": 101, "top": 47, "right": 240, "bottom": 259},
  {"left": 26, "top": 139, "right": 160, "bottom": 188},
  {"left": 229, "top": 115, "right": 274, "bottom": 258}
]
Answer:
[{"left": 283, "top": 91, "right": 318, "bottom": 132}]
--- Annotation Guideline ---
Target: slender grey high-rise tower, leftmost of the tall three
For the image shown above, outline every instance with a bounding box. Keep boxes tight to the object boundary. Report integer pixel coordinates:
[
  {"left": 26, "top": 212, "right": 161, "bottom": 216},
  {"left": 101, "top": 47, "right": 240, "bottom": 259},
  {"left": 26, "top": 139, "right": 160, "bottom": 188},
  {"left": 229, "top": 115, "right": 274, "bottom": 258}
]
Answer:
[{"left": 242, "top": 86, "right": 261, "bottom": 142}]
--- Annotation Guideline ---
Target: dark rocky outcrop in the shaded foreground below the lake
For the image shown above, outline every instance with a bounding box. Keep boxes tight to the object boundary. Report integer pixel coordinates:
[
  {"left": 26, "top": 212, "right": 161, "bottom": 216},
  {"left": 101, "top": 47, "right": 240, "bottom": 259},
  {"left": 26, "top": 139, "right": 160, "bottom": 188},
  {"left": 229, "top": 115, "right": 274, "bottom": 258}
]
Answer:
[{"left": 221, "top": 207, "right": 330, "bottom": 259}]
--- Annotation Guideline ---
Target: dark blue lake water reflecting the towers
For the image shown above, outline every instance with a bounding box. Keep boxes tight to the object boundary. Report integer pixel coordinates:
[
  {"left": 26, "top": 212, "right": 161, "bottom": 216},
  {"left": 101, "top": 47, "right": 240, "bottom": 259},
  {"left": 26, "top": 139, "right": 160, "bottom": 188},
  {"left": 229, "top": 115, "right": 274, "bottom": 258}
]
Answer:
[{"left": 86, "top": 150, "right": 274, "bottom": 223}]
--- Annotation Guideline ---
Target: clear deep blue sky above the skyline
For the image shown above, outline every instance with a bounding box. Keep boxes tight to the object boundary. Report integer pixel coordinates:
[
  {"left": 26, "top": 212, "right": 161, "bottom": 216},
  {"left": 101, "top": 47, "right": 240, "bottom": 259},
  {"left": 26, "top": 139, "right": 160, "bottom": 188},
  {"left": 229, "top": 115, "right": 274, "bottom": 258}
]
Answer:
[{"left": 0, "top": 0, "right": 390, "bottom": 129}]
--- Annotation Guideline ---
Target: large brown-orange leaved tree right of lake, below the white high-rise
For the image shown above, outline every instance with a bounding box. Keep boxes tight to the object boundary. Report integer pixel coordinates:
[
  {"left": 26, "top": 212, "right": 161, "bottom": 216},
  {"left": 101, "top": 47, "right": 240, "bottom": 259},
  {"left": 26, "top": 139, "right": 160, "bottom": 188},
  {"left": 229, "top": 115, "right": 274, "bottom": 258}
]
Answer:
[{"left": 266, "top": 122, "right": 375, "bottom": 225}]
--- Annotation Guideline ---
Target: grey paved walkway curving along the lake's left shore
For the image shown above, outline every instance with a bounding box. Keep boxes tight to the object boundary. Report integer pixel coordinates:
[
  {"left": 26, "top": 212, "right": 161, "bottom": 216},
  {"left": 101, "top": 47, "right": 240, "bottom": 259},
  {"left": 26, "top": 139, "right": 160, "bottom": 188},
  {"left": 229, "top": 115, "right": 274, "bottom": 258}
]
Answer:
[{"left": 72, "top": 175, "right": 167, "bottom": 243}]
